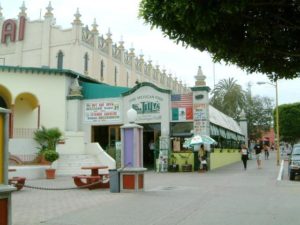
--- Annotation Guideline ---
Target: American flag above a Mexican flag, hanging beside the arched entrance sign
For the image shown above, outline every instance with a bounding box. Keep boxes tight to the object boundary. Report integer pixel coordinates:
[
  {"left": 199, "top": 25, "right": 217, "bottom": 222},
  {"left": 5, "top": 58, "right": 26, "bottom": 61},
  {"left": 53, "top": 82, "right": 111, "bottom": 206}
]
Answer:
[{"left": 171, "top": 93, "right": 193, "bottom": 121}]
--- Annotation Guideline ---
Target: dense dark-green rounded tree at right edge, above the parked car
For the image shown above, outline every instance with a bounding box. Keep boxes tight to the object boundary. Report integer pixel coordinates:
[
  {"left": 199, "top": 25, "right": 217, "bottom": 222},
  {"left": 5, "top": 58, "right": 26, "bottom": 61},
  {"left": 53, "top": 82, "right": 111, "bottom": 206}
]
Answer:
[{"left": 274, "top": 103, "right": 300, "bottom": 144}]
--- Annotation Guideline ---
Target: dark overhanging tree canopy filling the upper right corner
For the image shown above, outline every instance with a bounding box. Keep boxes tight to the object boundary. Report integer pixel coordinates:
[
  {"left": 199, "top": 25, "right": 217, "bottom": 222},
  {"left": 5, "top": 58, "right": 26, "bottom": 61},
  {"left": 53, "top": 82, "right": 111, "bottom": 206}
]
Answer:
[{"left": 140, "top": 0, "right": 300, "bottom": 80}]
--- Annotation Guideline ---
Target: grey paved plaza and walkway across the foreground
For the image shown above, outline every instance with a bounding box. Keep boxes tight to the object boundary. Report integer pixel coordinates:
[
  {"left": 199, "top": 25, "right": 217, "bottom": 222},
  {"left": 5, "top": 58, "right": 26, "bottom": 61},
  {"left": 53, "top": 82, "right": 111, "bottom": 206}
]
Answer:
[{"left": 12, "top": 152, "right": 300, "bottom": 225}]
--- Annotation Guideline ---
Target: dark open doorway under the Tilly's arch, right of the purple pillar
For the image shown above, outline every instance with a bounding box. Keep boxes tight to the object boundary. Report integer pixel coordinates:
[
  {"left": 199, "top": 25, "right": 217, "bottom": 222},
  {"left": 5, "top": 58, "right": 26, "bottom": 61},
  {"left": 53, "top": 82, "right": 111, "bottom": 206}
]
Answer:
[{"left": 139, "top": 123, "right": 161, "bottom": 170}]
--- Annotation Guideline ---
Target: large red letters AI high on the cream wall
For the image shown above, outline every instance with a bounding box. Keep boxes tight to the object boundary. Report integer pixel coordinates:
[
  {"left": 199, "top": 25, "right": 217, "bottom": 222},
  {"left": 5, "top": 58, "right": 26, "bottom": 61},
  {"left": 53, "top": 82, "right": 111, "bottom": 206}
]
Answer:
[{"left": 1, "top": 16, "right": 26, "bottom": 44}]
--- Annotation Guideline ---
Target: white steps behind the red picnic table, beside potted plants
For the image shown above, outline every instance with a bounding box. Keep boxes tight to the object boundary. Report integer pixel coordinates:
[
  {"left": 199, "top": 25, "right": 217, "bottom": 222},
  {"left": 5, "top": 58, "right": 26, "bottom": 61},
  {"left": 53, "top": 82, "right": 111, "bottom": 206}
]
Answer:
[{"left": 56, "top": 154, "right": 106, "bottom": 176}]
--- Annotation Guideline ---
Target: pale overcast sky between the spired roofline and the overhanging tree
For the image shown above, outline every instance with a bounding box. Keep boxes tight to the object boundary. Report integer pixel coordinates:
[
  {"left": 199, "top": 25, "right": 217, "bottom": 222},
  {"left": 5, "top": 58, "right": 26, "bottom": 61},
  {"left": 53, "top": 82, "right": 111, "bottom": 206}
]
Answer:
[{"left": 0, "top": 0, "right": 300, "bottom": 105}]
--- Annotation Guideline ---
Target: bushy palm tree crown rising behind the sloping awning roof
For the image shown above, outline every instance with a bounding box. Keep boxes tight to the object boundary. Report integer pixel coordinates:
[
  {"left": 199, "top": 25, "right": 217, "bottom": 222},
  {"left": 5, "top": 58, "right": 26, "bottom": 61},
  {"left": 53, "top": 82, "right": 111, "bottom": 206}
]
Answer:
[{"left": 210, "top": 77, "right": 246, "bottom": 119}]
